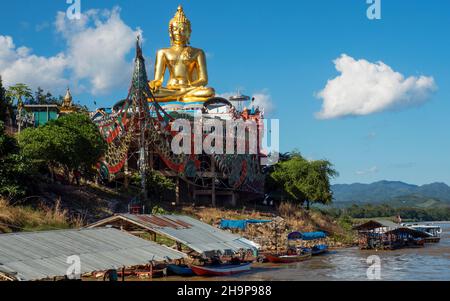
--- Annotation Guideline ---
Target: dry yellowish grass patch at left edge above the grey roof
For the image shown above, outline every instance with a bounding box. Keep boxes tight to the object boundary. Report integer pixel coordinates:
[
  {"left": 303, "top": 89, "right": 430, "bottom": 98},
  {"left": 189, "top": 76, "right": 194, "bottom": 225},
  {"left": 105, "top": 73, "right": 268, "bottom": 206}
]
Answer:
[{"left": 0, "top": 199, "right": 83, "bottom": 233}]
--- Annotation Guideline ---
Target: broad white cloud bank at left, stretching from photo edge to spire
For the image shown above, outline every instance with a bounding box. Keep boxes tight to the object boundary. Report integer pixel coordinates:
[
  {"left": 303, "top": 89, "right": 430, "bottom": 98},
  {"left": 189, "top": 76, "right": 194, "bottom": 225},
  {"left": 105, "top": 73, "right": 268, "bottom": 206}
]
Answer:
[{"left": 0, "top": 7, "right": 141, "bottom": 95}]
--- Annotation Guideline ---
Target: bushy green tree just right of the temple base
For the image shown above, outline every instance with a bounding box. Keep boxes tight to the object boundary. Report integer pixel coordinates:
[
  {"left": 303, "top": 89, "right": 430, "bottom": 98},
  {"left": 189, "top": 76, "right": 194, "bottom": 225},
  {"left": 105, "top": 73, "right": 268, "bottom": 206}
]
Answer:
[{"left": 268, "top": 152, "right": 338, "bottom": 209}]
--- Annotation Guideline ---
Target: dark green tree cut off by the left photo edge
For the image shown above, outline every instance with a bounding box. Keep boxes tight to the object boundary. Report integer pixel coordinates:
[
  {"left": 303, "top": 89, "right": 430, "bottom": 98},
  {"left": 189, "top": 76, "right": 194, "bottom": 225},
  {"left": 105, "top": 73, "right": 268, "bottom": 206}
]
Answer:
[{"left": 0, "top": 121, "right": 32, "bottom": 198}]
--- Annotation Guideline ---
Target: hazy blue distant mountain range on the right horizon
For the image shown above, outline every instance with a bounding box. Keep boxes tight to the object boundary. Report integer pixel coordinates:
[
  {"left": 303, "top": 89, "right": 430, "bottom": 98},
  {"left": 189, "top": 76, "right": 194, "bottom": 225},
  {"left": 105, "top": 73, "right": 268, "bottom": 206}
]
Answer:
[{"left": 331, "top": 181, "right": 450, "bottom": 207}]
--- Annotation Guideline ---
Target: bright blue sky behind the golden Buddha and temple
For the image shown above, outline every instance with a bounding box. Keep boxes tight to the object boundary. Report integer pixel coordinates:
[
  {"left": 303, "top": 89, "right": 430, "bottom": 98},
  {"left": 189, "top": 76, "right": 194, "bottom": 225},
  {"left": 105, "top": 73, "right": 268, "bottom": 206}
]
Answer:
[{"left": 0, "top": 0, "right": 450, "bottom": 184}]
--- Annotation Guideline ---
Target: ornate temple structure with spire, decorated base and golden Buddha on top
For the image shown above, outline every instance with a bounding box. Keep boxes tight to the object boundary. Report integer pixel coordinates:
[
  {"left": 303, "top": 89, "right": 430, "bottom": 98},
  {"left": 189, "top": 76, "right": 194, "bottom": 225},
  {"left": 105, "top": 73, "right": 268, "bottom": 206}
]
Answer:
[{"left": 93, "top": 6, "right": 264, "bottom": 205}]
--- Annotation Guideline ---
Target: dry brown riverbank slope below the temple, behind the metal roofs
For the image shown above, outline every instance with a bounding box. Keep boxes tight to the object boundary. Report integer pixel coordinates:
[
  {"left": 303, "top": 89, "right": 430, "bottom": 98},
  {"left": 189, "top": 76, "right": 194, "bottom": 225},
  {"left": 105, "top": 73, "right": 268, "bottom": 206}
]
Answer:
[{"left": 0, "top": 179, "right": 357, "bottom": 251}]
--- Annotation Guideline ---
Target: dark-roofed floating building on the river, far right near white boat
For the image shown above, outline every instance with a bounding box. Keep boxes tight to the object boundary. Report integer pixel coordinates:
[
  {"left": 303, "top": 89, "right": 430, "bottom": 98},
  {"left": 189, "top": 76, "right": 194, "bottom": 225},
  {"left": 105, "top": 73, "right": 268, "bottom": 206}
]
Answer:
[{"left": 353, "top": 220, "right": 427, "bottom": 250}]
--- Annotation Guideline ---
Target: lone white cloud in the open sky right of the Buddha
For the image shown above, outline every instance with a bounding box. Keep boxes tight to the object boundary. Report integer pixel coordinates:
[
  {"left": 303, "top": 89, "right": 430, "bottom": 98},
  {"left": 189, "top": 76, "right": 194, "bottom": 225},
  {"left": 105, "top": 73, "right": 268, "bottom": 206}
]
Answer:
[{"left": 316, "top": 54, "right": 436, "bottom": 119}]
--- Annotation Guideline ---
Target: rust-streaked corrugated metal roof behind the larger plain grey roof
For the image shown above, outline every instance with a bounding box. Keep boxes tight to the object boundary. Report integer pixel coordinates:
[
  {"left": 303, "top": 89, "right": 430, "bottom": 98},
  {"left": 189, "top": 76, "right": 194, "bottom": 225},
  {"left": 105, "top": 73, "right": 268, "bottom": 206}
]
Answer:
[{"left": 90, "top": 214, "right": 255, "bottom": 254}]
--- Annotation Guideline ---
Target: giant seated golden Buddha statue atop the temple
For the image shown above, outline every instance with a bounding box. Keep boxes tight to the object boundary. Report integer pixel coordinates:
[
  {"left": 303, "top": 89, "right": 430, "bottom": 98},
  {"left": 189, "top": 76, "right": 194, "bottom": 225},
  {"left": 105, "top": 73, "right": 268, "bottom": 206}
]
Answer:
[{"left": 149, "top": 6, "right": 215, "bottom": 103}]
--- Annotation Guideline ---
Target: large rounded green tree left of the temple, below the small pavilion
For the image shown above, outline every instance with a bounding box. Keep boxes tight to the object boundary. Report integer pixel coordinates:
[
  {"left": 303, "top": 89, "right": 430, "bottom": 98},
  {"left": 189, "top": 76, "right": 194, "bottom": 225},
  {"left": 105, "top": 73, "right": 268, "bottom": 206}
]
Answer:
[{"left": 19, "top": 113, "right": 106, "bottom": 175}]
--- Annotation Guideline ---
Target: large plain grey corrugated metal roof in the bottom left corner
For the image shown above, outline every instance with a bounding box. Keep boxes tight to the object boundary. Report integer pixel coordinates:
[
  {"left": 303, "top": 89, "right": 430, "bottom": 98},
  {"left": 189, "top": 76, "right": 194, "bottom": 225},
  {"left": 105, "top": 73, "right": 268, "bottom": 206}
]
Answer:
[{"left": 0, "top": 228, "right": 186, "bottom": 280}]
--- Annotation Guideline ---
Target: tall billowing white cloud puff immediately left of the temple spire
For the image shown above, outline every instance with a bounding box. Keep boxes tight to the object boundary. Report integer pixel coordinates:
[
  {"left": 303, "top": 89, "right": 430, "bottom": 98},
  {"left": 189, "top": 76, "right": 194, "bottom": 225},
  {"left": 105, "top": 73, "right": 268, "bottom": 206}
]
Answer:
[{"left": 55, "top": 7, "right": 141, "bottom": 95}]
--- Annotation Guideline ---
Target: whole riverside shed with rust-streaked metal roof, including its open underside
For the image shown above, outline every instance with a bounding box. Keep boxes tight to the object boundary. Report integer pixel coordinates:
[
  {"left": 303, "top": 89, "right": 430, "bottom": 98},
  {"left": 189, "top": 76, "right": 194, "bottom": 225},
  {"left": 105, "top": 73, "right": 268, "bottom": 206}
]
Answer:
[{"left": 88, "top": 214, "right": 257, "bottom": 257}]
